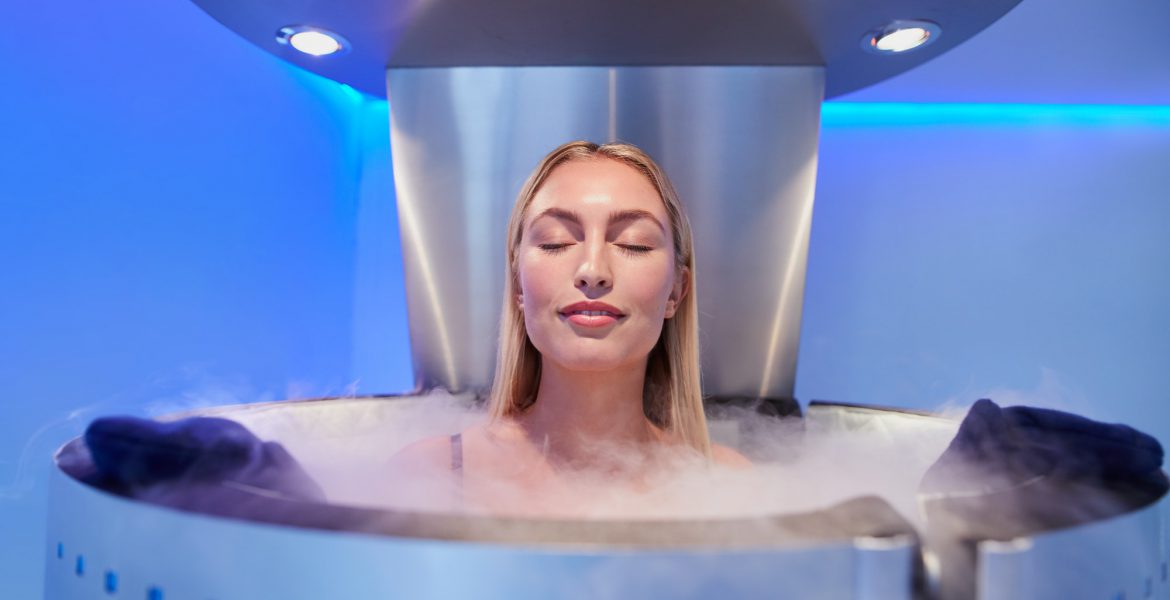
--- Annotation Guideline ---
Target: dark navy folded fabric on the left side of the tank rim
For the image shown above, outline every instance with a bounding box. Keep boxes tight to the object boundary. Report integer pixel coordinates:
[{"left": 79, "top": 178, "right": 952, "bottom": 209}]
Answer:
[{"left": 85, "top": 416, "right": 324, "bottom": 501}]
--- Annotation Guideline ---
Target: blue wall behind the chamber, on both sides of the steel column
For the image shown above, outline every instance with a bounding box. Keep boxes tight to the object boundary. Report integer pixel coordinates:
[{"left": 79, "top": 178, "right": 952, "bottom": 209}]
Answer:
[{"left": 0, "top": 0, "right": 1170, "bottom": 598}]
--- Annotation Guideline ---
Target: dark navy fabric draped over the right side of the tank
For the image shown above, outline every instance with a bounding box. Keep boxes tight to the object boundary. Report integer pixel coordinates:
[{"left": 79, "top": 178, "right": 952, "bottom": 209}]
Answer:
[{"left": 918, "top": 400, "right": 1170, "bottom": 600}]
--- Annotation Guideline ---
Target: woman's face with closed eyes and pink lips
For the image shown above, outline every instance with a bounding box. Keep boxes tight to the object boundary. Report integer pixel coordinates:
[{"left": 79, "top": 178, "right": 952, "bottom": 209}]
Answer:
[{"left": 516, "top": 158, "right": 689, "bottom": 371}]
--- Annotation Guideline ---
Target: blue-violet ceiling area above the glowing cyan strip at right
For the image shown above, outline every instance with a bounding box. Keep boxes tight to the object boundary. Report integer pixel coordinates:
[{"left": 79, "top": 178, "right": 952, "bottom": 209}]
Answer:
[{"left": 835, "top": 0, "right": 1170, "bottom": 105}]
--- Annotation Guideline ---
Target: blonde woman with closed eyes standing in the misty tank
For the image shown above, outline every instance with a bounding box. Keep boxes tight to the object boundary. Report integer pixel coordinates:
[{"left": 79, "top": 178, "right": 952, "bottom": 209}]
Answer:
[{"left": 392, "top": 142, "right": 750, "bottom": 516}]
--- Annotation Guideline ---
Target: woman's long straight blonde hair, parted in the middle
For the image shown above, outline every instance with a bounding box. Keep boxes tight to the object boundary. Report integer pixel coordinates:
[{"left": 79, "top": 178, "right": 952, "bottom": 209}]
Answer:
[{"left": 488, "top": 142, "right": 710, "bottom": 456}]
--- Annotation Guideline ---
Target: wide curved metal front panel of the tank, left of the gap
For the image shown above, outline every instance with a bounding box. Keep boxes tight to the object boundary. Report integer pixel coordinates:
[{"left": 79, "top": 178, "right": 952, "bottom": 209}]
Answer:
[{"left": 43, "top": 451, "right": 861, "bottom": 600}]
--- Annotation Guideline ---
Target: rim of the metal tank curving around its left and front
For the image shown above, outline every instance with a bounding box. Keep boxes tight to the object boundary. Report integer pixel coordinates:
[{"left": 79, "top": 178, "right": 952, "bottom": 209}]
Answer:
[{"left": 54, "top": 393, "right": 921, "bottom": 550}]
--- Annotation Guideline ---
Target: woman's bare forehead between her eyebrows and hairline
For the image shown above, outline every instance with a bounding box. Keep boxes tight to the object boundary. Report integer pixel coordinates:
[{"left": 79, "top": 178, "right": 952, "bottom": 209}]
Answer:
[{"left": 527, "top": 158, "right": 668, "bottom": 225}]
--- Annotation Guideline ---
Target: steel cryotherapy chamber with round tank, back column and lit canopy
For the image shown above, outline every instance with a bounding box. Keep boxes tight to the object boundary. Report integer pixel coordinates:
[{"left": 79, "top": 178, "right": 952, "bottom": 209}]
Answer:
[{"left": 46, "top": 0, "right": 1170, "bottom": 599}]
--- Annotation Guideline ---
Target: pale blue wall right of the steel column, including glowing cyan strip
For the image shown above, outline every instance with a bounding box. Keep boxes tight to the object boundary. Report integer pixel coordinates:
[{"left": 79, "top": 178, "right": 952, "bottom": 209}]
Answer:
[{"left": 797, "top": 104, "right": 1170, "bottom": 432}]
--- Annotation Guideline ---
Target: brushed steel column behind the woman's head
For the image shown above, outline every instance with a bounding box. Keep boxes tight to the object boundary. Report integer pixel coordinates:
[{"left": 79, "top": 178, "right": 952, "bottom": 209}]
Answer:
[{"left": 387, "top": 67, "right": 824, "bottom": 398}]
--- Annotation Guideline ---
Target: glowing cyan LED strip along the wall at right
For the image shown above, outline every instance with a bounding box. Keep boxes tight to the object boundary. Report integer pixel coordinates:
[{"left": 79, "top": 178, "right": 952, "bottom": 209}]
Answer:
[{"left": 821, "top": 102, "right": 1170, "bottom": 127}]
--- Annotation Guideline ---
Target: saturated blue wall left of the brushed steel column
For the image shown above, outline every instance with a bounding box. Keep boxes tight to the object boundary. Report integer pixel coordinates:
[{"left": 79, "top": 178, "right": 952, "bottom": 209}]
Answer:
[{"left": 0, "top": 0, "right": 411, "bottom": 599}]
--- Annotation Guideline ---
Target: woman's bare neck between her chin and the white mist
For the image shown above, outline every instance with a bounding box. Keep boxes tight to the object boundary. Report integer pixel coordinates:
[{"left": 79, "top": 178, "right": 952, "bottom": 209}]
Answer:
[{"left": 516, "top": 360, "right": 655, "bottom": 465}]
